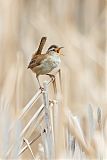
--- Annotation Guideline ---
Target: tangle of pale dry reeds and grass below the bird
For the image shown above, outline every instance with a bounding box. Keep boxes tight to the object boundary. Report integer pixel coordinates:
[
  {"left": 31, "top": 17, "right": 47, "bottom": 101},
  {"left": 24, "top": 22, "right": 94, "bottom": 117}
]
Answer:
[{"left": 1, "top": 73, "right": 107, "bottom": 159}]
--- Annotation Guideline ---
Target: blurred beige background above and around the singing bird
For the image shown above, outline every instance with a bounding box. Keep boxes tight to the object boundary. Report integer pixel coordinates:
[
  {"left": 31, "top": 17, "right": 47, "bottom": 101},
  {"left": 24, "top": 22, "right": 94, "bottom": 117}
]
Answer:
[{"left": 0, "top": 0, "right": 107, "bottom": 158}]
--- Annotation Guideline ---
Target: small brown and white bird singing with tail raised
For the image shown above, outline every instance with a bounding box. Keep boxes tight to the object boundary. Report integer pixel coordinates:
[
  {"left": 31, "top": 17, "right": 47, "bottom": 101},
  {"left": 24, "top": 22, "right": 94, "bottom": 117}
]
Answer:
[{"left": 28, "top": 37, "right": 63, "bottom": 90}]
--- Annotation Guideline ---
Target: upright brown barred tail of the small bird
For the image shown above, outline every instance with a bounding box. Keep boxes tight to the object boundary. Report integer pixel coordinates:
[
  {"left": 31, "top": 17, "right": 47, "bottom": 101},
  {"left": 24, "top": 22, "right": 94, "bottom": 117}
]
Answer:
[{"left": 32, "top": 37, "right": 47, "bottom": 58}]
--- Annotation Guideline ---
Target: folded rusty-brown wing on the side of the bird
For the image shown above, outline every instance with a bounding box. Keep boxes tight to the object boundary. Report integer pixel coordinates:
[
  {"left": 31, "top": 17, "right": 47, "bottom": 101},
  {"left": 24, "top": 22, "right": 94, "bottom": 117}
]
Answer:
[{"left": 28, "top": 54, "right": 48, "bottom": 68}]
